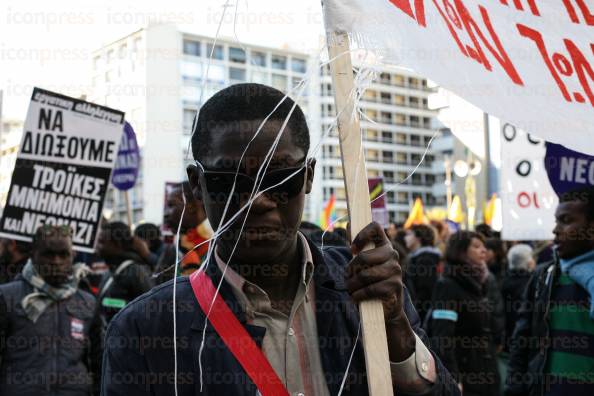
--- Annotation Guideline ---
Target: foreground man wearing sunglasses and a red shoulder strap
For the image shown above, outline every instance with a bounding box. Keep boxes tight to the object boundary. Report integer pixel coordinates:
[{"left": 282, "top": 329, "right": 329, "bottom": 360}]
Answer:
[{"left": 103, "top": 84, "right": 459, "bottom": 396}]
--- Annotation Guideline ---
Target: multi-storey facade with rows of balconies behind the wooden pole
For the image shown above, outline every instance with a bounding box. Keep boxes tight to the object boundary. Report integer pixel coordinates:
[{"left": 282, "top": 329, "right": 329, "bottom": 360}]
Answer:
[{"left": 318, "top": 67, "right": 445, "bottom": 226}]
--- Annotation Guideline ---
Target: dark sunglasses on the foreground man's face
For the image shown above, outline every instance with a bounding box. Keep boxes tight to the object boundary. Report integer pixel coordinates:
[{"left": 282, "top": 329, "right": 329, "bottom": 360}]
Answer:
[{"left": 195, "top": 160, "right": 309, "bottom": 203}]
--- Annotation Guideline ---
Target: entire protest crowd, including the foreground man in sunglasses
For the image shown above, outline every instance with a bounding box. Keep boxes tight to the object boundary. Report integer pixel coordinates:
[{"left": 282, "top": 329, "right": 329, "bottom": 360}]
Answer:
[{"left": 0, "top": 84, "right": 594, "bottom": 396}]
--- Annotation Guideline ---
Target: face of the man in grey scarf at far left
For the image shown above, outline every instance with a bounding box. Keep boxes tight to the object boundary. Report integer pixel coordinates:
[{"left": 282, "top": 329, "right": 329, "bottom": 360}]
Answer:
[{"left": 33, "top": 235, "right": 73, "bottom": 286}]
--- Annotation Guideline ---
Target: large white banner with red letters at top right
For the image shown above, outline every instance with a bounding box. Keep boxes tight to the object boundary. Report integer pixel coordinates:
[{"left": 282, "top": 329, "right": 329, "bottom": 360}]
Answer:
[{"left": 323, "top": 0, "right": 594, "bottom": 154}]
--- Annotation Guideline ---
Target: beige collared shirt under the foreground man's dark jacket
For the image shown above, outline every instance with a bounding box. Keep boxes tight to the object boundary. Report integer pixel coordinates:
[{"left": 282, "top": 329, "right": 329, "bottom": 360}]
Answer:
[{"left": 215, "top": 233, "right": 436, "bottom": 396}]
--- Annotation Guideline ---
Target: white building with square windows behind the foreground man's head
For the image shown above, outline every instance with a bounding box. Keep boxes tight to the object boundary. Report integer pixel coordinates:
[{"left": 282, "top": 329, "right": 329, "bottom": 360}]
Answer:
[{"left": 88, "top": 25, "right": 318, "bottom": 224}]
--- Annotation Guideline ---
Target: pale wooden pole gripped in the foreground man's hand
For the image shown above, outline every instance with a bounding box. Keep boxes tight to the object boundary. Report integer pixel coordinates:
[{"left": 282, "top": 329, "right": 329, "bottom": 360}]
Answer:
[{"left": 327, "top": 33, "right": 394, "bottom": 396}]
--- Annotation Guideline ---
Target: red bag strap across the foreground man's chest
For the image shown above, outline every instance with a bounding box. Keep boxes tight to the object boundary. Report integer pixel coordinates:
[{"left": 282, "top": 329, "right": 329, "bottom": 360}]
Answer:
[{"left": 190, "top": 271, "right": 289, "bottom": 396}]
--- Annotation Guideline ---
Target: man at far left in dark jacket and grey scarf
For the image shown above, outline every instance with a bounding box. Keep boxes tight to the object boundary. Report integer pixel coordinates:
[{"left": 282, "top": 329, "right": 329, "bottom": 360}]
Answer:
[{"left": 0, "top": 225, "right": 101, "bottom": 396}]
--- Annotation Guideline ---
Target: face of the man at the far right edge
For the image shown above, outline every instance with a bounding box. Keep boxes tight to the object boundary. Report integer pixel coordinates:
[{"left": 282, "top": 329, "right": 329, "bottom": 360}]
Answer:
[{"left": 553, "top": 201, "right": 594, "bottom": 259}]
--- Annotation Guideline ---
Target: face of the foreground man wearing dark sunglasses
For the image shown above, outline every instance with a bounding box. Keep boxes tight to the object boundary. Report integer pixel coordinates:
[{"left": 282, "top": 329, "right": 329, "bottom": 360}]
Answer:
[{"left": 188, "top": 121, "right": 315, "bottom": 263}]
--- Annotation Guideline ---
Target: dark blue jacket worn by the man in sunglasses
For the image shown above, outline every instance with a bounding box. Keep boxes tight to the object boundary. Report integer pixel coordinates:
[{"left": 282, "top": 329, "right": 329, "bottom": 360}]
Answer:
[{"left": 102, "top": 243, "right": 459, "bottom": 396}]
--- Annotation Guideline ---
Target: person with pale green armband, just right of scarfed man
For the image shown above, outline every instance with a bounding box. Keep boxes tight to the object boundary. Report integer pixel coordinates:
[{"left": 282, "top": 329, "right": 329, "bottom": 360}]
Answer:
[{"left": 96, "top": 221, "right": 154, "bottom": 328}]
